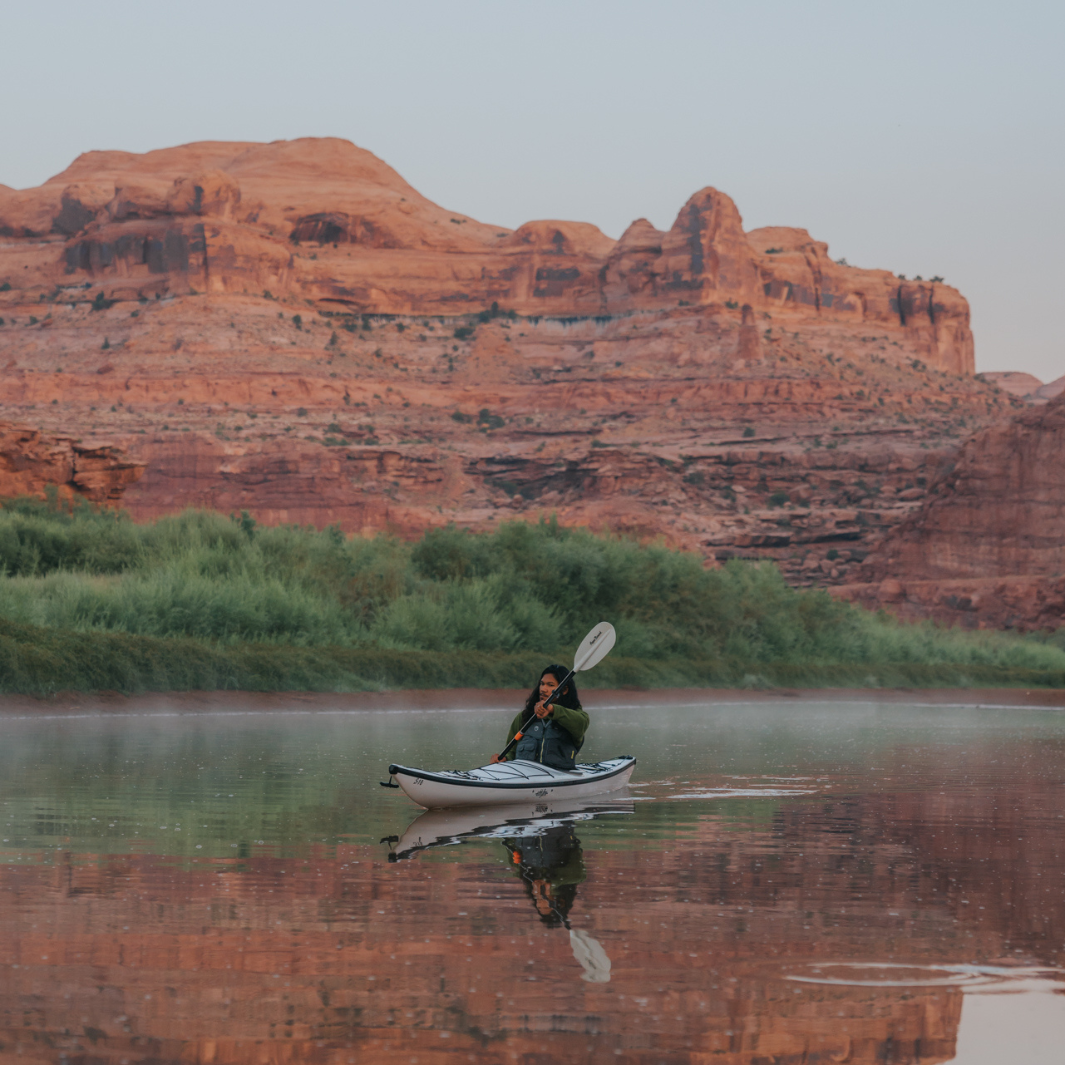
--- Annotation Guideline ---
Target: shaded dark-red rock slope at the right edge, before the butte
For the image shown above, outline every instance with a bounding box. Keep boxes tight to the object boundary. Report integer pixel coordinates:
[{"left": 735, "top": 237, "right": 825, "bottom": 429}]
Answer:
[{"left": 847, "top": 396, "right": 1065, "bottom": 628}]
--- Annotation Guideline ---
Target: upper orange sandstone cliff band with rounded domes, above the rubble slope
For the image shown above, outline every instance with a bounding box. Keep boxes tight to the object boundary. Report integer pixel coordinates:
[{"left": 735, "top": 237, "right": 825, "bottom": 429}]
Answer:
[{"left": 0, "top": 138, "right": 972, "bottom": 373}]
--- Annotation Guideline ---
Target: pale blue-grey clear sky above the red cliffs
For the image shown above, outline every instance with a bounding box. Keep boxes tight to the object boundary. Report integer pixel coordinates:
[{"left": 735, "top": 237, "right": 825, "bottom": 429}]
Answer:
[{"left": 0, "top": 0, "right": 1065, "bottom": 380}]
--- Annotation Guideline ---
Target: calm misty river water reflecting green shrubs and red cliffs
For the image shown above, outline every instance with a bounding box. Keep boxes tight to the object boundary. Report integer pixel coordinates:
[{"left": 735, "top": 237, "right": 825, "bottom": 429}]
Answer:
[{"left": 0, "top": 700, "right": 1065, "bottom": 1065}]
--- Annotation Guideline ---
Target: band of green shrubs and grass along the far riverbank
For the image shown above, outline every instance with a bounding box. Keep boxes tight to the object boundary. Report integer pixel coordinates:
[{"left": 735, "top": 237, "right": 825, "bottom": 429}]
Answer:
[{"left": 0, "top": 499, "right": 1065, "bottom": 692}]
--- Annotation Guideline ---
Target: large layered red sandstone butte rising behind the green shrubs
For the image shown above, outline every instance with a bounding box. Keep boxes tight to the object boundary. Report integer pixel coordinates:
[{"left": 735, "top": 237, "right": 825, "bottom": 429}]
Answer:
[{"left": 0, "top": 138, "right": 1047, "bottom": 621}]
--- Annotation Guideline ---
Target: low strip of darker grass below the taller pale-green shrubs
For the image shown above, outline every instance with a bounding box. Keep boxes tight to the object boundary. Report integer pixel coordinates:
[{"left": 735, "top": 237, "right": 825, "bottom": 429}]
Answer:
[{"left": 0, "top": 619, "right": 1065, "bottom": 698}]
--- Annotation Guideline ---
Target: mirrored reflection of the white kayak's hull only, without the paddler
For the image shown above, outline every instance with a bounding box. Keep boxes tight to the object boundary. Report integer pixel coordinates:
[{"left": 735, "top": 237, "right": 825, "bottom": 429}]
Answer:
[{"left": 386, "top": 799, "right": 635, "bottom": 862}]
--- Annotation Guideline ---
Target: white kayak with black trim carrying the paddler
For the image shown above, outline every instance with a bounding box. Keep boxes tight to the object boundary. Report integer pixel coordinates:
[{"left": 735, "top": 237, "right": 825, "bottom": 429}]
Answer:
[{"left": 389, "top": 755, "right": 636, "bottom": 809}]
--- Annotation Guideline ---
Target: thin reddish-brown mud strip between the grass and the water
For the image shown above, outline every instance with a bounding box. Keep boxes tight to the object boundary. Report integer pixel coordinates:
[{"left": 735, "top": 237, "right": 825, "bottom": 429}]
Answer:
[{"left": 0, "top": 688, "right": 1065, "bottom": 716}]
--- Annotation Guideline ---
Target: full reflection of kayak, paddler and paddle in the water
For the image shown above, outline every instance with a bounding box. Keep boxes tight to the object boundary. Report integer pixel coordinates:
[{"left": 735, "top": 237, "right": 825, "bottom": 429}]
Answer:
[{"left": 387, "top": 801, "right": 635, "bottom": 984}]
